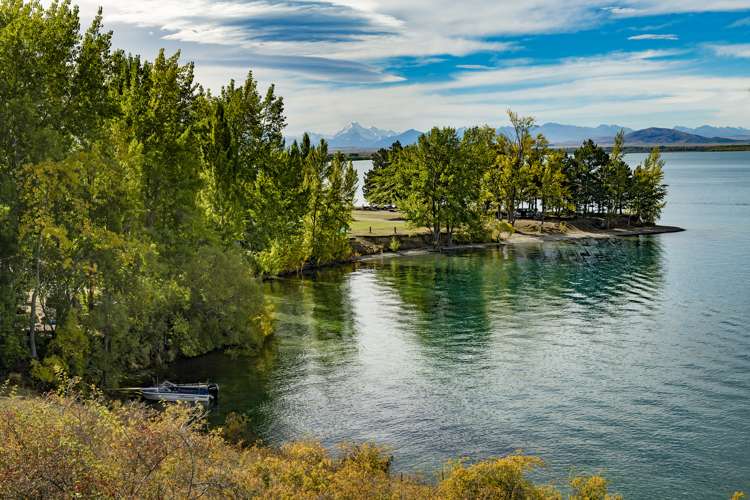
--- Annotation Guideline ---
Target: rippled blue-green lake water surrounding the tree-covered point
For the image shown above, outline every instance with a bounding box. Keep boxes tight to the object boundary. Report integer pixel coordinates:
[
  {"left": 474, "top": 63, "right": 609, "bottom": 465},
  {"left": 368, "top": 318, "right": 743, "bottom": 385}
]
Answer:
[{"left": 171, "top": 152, "right": 750, "bottom": 498}]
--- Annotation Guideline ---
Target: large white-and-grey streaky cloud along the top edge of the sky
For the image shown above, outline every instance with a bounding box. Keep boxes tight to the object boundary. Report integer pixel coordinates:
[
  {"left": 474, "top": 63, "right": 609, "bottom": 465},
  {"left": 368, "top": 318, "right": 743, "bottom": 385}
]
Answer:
[{"left": 72, "top": 0, "right": 750, "bottom": 60}]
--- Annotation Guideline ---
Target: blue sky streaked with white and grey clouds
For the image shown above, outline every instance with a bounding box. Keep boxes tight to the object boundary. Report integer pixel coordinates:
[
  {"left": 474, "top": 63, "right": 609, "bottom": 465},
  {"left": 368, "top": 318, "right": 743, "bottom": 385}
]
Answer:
[{"left": 66, "top": 0, "right": 750, "bottom": 134}]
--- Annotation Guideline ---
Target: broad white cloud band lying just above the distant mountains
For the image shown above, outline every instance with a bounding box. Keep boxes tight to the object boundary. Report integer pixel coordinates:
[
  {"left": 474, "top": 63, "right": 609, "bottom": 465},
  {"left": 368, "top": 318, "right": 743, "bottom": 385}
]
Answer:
[{"left": 272, "top": 51, "right": 750, "bottom": 134}]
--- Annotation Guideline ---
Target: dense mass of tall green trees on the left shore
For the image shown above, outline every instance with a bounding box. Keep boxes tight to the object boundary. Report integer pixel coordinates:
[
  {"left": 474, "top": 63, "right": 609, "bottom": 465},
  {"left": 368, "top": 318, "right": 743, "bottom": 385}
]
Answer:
[{"left": 0, "top": 0, "right": 357, "bottom": 386}]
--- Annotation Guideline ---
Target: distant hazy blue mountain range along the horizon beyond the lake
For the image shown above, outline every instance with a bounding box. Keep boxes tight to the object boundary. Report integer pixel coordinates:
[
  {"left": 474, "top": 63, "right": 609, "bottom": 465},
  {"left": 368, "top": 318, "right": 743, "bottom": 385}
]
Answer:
[{"left": 287, "top": 122, "right": 750, "bottom": 150}]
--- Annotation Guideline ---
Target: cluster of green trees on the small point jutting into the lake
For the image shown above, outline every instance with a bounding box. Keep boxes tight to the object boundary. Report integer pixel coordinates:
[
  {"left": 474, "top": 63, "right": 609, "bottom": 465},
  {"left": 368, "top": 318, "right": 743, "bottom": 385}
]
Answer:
[{"left": 365, "top": 110, "right": 666, "bottom": 246}]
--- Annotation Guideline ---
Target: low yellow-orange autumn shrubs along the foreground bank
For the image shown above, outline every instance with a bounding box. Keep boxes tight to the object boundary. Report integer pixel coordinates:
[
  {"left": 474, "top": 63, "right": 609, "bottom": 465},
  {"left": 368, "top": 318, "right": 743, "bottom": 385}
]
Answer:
[{"left": 0, "top": 382, "right": 618, "bottom": 500}]
